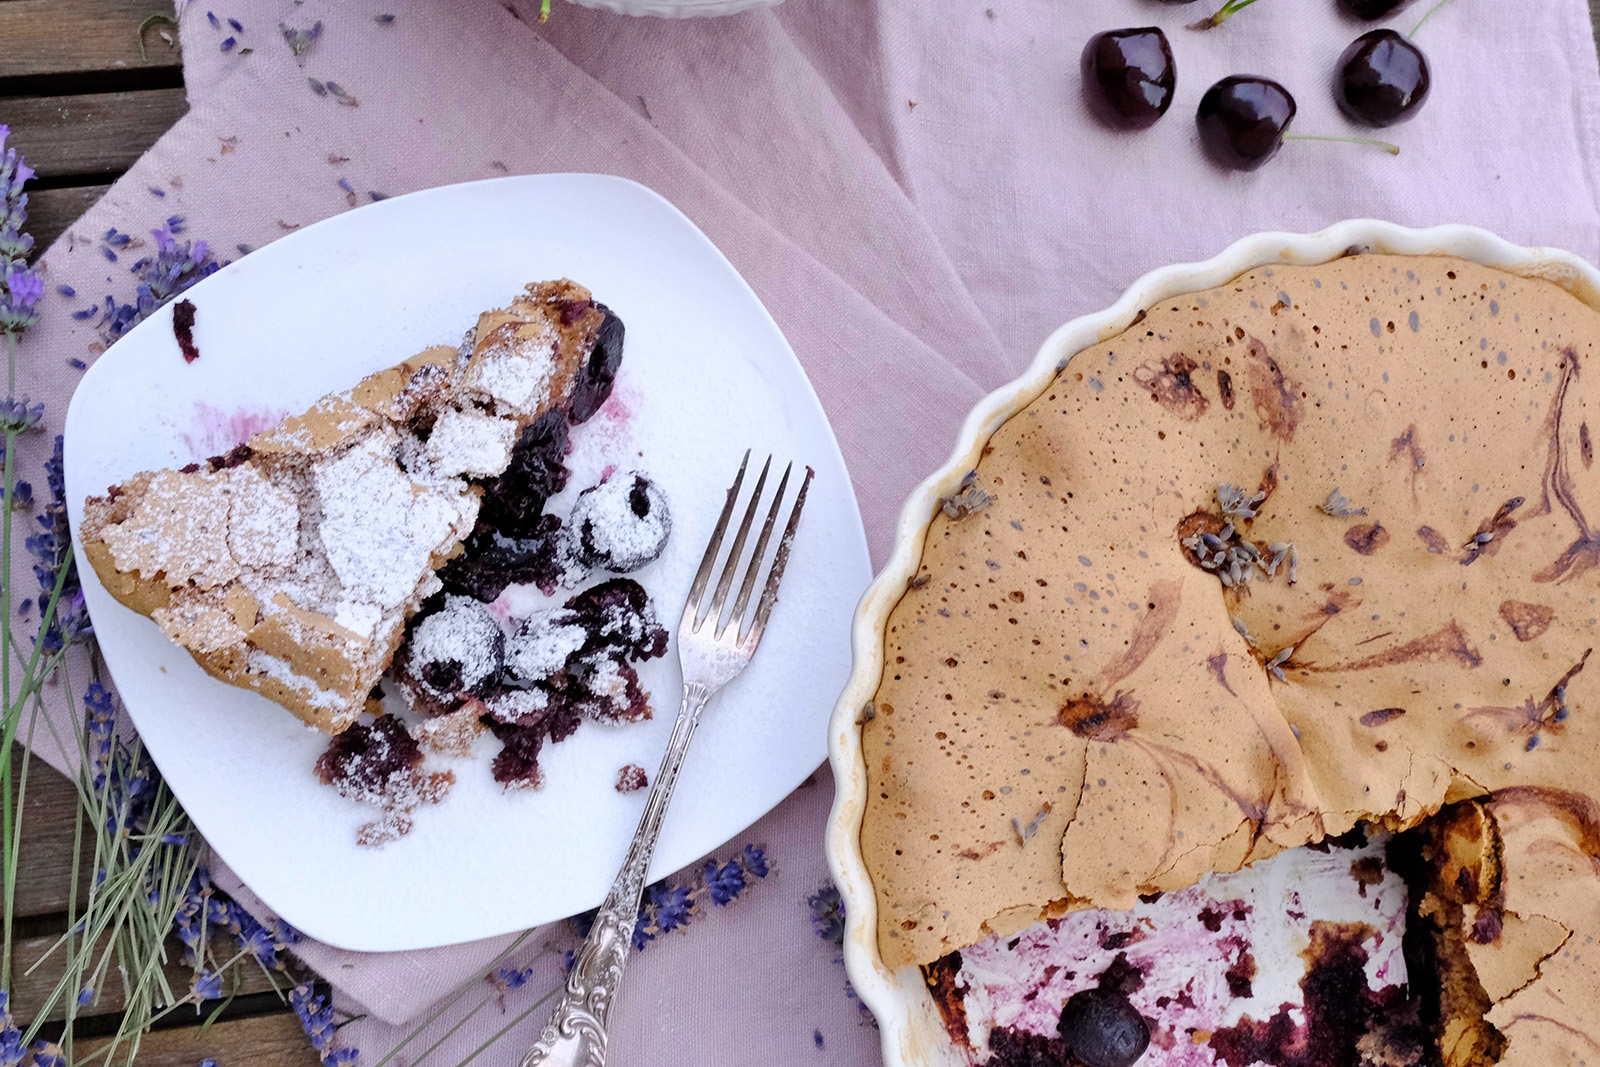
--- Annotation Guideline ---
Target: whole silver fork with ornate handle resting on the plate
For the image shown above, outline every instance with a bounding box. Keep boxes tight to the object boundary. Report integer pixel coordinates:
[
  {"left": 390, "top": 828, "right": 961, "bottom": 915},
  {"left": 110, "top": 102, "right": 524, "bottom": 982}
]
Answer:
[{"left": 522, "top": 451, "right": 811, "bottom": 1067}]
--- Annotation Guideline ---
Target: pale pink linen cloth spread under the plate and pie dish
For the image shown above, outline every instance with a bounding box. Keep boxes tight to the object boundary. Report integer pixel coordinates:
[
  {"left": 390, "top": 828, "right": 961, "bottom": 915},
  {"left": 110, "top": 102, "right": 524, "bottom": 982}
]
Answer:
[{"left": 12, "top": 0, "right": 1600, "bottom": 1065}]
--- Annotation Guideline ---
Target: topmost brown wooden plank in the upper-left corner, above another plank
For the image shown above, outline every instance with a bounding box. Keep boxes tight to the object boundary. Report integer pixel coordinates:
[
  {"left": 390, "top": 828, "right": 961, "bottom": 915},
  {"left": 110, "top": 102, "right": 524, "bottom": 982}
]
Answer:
[{"left": 0, "top": 0, "right": 181, "bottom": 78}]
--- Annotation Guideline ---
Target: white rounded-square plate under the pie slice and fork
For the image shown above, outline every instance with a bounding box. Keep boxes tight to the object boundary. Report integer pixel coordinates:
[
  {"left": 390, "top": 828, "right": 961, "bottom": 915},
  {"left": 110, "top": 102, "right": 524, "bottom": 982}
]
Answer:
[{"left": 66, "top": 174, "right": 870, "bottom": 952}]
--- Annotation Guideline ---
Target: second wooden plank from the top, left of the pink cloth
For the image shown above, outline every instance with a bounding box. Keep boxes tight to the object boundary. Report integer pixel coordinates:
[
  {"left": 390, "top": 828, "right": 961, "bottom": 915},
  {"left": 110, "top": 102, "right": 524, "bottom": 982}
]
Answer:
[{"left": 0, "top": 91, "right": 189, "bottom": 184}]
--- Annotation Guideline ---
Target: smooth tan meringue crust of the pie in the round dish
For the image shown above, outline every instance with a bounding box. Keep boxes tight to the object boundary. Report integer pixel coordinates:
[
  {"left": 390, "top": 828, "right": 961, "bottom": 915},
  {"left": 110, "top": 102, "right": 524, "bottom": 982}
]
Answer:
[{"left": 861, "top": 254, "right": 1600, "bottom": 1065}]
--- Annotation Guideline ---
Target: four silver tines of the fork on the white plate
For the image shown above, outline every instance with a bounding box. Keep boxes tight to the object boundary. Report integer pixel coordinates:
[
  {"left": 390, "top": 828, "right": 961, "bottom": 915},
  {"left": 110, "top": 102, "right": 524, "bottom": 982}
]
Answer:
[{"left": 680, "top": 451, "right": 814, "bottom": 648}]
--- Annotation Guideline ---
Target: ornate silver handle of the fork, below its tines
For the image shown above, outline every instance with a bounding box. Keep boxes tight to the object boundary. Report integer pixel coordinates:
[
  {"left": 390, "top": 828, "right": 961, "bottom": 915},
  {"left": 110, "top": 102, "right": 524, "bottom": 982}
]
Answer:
[{"left": 522, "top": 681, "right": 710, "bottom": 1067}]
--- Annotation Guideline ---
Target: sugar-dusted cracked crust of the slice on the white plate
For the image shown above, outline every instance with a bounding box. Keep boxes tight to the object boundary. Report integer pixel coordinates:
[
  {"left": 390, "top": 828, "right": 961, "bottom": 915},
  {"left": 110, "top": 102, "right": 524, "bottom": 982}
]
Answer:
[{"left": 78, "top": 278, "right": 605, "bottom": 733}]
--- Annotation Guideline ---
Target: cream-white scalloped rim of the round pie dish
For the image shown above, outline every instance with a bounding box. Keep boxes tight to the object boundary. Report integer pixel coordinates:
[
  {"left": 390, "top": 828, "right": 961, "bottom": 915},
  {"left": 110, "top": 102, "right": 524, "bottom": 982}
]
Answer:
[{"left": 827, "top": 219, "right": 1600, "bottom": 1067}]
